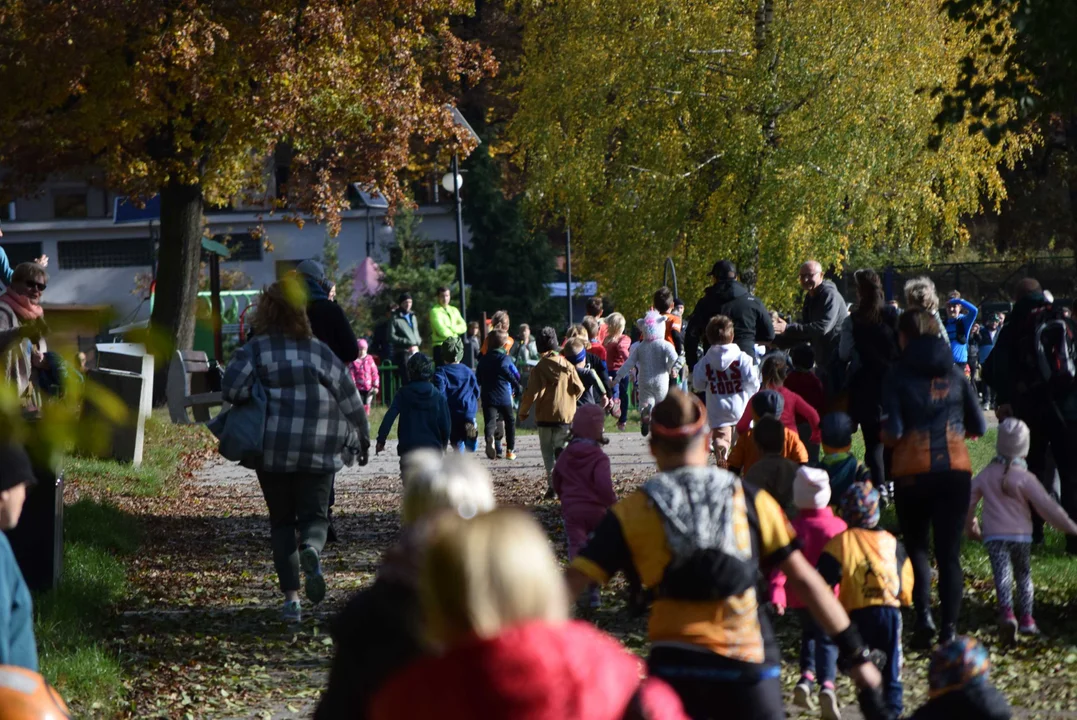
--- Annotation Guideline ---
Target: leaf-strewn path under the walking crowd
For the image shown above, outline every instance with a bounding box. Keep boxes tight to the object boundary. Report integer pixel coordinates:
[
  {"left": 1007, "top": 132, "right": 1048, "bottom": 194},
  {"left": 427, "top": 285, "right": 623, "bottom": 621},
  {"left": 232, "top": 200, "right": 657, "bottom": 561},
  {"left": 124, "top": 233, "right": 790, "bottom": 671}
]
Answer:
[{"left": 113, "top": 433, "right": 1077, "bottom": 720}]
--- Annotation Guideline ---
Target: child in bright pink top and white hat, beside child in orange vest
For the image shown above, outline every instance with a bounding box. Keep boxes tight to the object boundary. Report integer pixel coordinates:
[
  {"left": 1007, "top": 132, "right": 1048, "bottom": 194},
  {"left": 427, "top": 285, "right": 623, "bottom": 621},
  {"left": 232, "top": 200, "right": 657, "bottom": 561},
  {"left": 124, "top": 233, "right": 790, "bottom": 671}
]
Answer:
[{"left": 770, "top": 465, "right": 847, "bottom": 717}]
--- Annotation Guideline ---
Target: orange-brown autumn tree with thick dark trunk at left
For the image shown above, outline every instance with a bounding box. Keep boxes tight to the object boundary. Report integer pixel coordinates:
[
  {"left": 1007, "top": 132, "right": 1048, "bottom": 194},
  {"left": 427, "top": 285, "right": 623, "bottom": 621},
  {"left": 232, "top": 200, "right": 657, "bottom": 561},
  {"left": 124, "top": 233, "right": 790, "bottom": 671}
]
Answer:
[{"left": 0, "top": 0, "right": 495, "bottom": 376}]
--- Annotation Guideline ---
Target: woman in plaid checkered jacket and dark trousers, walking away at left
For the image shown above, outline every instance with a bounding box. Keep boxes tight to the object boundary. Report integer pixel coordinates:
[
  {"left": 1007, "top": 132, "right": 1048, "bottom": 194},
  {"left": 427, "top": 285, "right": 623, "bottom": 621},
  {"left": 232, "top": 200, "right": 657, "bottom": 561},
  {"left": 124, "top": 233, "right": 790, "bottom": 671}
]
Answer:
[{"left": 221, "top": 283, "right": 370, "bottom": 622}]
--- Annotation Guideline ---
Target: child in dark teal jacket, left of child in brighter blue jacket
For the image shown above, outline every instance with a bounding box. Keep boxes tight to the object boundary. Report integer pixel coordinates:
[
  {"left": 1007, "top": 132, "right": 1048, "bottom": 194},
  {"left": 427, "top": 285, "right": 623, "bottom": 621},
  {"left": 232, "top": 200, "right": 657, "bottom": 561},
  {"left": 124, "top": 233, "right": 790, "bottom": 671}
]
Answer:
[{"left": 375, "top": 353, "right": 450, "bottom": 467}]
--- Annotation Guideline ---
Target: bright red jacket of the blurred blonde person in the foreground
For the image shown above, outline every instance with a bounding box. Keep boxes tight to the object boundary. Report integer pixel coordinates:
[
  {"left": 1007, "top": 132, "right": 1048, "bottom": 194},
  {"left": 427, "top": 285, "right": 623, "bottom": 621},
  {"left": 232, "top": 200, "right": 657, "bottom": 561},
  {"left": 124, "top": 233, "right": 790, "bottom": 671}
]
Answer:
[{"left": 369, "top": 622, "right": 688, "bottom": 720}]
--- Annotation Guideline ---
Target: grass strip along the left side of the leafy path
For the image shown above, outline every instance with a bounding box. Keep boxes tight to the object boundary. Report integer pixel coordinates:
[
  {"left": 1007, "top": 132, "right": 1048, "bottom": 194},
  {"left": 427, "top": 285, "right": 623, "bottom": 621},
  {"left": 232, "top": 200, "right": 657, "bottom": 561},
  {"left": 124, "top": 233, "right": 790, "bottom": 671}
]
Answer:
[{"left": 34, "top": 409, "right": 214, "bottom": 717}]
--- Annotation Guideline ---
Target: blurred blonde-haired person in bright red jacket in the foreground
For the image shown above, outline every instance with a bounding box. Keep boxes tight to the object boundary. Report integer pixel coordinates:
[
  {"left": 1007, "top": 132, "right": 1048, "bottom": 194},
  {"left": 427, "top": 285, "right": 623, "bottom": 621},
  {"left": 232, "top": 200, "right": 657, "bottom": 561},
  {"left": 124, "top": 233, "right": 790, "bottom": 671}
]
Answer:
[{"left": 370, "top": 509, "right": 686, "bottom": 720}]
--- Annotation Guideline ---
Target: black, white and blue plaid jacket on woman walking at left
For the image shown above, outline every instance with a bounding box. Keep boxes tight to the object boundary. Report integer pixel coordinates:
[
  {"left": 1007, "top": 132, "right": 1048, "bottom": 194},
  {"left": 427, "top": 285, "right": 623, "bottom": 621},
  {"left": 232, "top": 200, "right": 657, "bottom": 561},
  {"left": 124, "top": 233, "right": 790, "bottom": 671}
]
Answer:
[{"left": 222, "top": 335, "right": 370, "bottom": 472}]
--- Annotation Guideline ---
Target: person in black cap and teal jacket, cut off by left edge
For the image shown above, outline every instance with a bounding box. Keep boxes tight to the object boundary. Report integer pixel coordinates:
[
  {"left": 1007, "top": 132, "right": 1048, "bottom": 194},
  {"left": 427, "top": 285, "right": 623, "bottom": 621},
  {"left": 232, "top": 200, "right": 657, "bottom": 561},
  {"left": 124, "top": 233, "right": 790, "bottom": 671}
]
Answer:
[{"left": 0, "top": 444, "right": 38, "bottom": 672}]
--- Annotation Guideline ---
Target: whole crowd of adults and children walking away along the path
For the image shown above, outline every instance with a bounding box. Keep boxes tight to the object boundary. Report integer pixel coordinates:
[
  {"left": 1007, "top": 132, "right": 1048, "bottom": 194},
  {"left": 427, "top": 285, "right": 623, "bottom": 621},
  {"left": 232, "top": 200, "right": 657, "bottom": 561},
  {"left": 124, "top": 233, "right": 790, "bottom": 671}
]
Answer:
[{"left": 0, "top": 243, "right": 1077, "bottom": 720}]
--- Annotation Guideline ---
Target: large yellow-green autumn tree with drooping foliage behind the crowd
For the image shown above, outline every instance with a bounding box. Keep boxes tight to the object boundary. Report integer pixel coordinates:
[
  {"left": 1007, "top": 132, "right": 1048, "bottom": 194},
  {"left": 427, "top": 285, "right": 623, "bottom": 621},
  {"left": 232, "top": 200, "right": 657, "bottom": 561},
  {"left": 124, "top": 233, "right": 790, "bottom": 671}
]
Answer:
[{"left": 514, "top": 0, "right": 1020, "bottom": 311}]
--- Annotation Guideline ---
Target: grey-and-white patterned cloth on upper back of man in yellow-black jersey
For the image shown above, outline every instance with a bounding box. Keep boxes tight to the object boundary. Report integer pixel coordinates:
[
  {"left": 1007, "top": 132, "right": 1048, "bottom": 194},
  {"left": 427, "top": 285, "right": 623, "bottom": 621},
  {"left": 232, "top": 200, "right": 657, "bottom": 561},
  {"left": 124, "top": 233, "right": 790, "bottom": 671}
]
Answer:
[{"left": 643, "top": 467, "right": 752, "bottom": 564}]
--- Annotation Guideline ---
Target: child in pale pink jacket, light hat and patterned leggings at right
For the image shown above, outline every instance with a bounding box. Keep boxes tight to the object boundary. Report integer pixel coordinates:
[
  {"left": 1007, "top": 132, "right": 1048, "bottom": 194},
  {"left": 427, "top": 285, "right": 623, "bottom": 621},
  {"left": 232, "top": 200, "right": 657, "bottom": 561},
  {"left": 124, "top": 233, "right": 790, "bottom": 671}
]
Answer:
[{"left": 966, "top": 418, "right": 1077, "bottom": 643}]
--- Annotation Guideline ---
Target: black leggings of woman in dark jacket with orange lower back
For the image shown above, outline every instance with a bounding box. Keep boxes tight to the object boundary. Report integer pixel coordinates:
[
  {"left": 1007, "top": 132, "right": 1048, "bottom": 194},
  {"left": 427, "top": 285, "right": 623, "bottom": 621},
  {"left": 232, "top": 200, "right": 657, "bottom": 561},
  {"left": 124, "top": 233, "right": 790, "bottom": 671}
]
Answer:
[{"left": 894, "top": 470, "right": 973, "bottom": 630}]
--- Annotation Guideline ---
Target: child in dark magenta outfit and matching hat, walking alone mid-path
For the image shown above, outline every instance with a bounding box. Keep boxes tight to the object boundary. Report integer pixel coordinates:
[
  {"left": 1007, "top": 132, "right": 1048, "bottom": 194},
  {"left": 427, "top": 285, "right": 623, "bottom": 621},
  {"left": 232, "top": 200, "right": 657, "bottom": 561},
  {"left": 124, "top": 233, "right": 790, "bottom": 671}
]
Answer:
[{"left": 553, "top": 405, "right": 617, "bottom": 607}]
